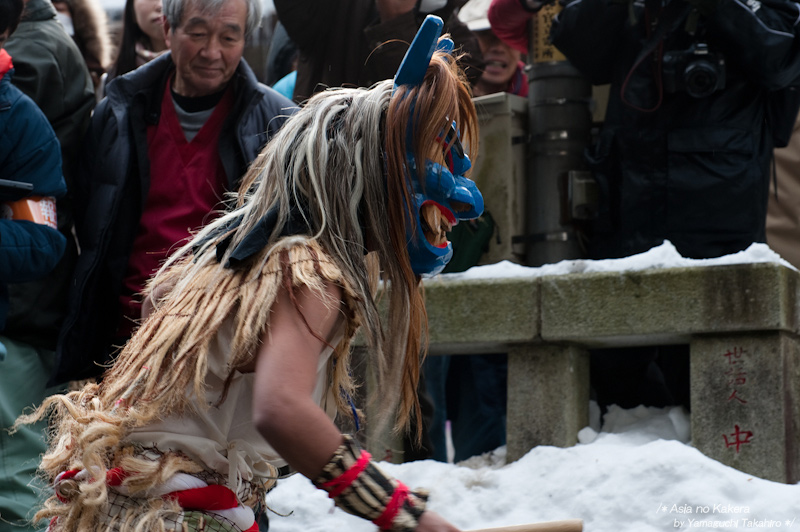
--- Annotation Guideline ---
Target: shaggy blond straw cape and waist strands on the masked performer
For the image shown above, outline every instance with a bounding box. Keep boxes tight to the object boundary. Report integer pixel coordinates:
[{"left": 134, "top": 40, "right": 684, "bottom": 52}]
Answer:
[{"left": 20, "top": 240, "right": 358, "bottom": 531}]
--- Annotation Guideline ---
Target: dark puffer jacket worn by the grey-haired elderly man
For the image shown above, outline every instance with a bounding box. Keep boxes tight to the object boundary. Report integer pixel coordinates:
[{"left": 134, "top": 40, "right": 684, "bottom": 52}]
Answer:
[{"left": 52, "top": 53, "right": 296, "bottom": 383}]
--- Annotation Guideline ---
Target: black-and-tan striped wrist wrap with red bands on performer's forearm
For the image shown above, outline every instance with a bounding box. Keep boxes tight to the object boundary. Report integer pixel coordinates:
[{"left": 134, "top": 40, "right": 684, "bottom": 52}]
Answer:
[{"left": 314, "top": 435, "right": 428, "bottom": 532}]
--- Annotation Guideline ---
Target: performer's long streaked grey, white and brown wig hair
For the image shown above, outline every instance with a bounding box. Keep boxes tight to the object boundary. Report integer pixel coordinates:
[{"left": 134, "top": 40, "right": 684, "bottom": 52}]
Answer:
[{"left": 143, "top": 42, "right": 478, "bottom": 436}]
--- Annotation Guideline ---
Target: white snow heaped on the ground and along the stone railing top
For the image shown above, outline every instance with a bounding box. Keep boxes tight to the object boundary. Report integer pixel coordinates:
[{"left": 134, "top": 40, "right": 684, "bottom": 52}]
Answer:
[{"left": 267, "top": 242, "right": 800, "bottom": 532}]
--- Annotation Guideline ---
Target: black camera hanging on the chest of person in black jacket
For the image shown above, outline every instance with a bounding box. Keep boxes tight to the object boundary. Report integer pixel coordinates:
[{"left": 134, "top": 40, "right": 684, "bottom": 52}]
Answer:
[{"left": 663, "top": 43, "right": 725, "bottom": 98}]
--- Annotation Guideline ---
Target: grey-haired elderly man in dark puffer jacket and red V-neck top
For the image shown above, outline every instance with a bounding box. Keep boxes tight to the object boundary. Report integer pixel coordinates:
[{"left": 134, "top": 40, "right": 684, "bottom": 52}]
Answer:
[{"left": 54, "top": 0, "right": 294, "bottom": 382}]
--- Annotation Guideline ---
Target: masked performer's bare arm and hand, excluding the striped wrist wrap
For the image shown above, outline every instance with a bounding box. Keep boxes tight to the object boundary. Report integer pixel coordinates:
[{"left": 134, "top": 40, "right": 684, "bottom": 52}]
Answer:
[{"left": 253, "top": 284, "right": 458, "bottom": 532}]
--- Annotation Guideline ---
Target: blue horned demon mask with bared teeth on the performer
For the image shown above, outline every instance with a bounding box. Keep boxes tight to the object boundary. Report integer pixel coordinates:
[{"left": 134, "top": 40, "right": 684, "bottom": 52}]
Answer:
[{"left": 394, "top": 15, "right": 483, "bottom": 275}]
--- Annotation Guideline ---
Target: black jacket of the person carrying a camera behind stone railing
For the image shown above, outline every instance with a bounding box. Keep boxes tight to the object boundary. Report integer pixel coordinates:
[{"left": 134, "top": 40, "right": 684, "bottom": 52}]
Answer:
[{"left": 551, "top": 0, "right": 800, "bottom": 258}]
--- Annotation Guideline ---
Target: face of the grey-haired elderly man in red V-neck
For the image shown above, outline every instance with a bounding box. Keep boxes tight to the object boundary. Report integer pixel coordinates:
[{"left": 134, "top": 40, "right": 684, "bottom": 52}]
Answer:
[{"left": 164, "top": 0, "right": 247, "bottom": 98}]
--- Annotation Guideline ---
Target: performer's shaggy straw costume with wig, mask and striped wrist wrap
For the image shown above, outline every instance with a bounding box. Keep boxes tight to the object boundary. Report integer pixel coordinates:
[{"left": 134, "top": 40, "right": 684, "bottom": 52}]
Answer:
[{"left": 22, "top": 15, "right": 482, "bottom": 532}]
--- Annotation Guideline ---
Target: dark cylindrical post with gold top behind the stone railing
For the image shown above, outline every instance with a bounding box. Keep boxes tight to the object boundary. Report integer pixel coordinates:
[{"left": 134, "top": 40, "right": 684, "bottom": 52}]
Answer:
[{"left": 521, "top": 5, "right": 593, "bottom": 266}]
